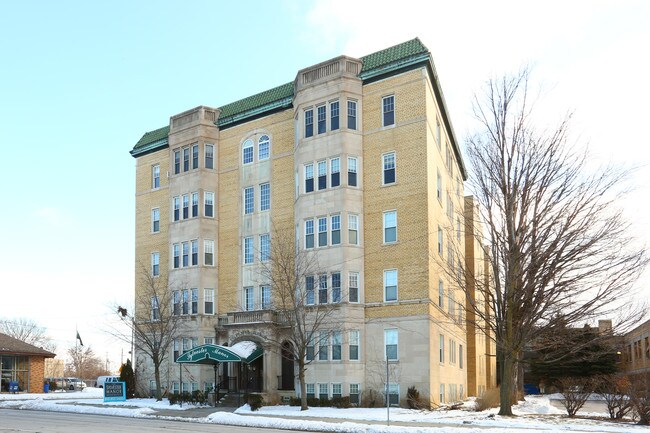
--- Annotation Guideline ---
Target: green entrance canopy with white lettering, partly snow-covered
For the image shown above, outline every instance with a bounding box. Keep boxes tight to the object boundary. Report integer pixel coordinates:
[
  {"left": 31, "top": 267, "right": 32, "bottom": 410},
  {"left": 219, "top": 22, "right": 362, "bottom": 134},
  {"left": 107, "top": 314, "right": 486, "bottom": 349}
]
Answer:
[{"left": 176, "top": 341, "right": 264, "bottom": 365}]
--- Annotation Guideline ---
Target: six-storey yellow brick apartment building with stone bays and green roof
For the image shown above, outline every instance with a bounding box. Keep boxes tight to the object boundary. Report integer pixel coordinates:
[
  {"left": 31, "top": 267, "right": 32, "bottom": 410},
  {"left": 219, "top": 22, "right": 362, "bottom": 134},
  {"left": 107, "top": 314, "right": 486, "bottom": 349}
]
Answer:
[{"left": 131, "top": 39, "right": 493, "bottom": 405}]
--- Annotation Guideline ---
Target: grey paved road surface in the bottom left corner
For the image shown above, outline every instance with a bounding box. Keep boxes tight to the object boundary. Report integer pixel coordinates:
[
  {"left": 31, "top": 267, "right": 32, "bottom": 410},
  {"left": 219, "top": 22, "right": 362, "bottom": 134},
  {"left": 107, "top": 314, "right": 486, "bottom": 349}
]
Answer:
[{"left": 0, "top": 409, "right": 312, "bottom": 433}]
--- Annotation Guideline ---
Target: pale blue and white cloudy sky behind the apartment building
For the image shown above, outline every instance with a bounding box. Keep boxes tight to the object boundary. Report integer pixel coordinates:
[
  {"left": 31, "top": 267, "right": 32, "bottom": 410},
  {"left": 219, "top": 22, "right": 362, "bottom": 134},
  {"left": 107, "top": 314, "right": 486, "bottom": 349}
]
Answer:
[{"left": 0, "top": 0, "right": 650, "bottom": 372}]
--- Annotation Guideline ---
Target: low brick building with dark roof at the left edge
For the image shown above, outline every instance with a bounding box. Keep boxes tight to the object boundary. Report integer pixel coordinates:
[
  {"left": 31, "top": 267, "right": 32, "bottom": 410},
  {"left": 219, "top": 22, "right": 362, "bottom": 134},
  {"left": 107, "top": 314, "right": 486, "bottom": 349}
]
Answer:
[{"left": 0, "top": 333, "right": 56, "bottom": 393}]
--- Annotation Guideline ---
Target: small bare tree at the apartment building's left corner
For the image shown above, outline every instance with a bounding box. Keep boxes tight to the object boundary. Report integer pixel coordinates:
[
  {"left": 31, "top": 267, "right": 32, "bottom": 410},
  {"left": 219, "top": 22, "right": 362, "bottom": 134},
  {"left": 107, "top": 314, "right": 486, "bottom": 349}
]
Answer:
[{"left": 111, "top": 266, "right": 180, "bottom": 400}]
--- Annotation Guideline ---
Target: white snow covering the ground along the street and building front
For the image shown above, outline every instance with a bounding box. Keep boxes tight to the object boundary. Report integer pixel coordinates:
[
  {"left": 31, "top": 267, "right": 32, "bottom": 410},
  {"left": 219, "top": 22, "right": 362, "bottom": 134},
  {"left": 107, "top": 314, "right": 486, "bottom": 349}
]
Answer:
[{"left": 0, "top": 388, "right": 649, "bottom": 433}]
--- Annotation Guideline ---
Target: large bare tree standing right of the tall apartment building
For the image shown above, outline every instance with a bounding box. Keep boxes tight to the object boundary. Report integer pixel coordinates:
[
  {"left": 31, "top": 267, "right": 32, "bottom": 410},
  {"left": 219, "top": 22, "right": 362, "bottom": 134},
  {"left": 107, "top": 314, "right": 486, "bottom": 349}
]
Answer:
[{"left": 466, "top": 69, "right": 648, "bottom": 415}]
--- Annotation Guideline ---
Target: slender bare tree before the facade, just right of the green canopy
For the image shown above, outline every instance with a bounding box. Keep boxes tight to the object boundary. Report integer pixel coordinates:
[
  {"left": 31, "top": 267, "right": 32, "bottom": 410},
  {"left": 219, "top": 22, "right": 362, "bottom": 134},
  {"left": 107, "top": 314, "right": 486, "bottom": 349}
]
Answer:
[{"left": 261, "top": 227, "right": 341, "bottom": 410}]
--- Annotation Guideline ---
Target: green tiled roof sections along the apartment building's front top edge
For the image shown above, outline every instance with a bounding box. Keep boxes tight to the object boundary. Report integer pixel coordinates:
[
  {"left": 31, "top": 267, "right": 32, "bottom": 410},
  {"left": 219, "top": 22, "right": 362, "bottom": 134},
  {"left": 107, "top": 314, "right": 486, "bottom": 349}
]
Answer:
[{"left": 131, "top": 38, "right": 429, "bottom": 156}]
